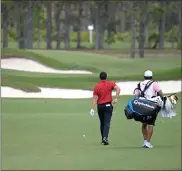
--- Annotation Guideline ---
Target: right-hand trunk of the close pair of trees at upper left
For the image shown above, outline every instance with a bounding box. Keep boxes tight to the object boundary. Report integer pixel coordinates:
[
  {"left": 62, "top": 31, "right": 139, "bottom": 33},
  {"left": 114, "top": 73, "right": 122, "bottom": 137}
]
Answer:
[{"left": 27, "top": 0, "right": 33, "bottom": 49}]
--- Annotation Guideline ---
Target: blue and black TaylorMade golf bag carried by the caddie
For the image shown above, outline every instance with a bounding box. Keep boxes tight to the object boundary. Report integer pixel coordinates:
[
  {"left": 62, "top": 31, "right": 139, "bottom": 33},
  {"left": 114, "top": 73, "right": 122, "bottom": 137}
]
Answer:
[{"left": 124, "top": 97, "right": 161, "bottom": 122}]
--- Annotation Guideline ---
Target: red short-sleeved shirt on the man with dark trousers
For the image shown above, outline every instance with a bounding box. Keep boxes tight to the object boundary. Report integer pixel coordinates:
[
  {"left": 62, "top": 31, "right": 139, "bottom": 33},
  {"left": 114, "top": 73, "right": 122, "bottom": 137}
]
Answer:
[{"left": 93, "top": 80, "right": 116, "bottom": 104}]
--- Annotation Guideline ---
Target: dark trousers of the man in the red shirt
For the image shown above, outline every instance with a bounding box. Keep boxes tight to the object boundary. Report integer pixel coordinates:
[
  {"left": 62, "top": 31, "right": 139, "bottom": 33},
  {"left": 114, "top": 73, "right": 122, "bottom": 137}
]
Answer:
[{"left": 97, "top": 103, "right": 113, "bottom": 139}]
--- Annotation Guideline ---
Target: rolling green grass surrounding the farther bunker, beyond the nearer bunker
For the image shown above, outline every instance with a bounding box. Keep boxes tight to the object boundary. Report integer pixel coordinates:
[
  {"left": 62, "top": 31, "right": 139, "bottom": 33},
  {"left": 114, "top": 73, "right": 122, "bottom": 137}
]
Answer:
[{"left": 1, "top": 49, "right": 181, "bottom": 91}]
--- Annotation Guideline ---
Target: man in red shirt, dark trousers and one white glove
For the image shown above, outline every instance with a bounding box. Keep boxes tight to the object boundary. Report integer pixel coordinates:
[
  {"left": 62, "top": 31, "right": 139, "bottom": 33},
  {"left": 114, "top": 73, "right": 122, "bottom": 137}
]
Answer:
[{"left": 90, "top": 72, "right": 120, "bottom": 145}]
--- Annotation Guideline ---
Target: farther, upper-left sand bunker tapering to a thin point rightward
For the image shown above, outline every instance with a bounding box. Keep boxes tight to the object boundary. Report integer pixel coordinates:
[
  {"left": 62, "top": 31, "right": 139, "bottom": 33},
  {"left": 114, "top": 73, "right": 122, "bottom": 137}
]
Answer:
[{"left": 1, "top": 58, "right": 92, "bottom": 74}]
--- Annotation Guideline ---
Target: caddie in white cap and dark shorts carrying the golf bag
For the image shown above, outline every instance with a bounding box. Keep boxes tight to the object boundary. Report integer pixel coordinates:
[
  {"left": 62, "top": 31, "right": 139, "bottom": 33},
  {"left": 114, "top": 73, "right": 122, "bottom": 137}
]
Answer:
[{"left": 134, "top": 70, "right": 163, "bottom": 148}]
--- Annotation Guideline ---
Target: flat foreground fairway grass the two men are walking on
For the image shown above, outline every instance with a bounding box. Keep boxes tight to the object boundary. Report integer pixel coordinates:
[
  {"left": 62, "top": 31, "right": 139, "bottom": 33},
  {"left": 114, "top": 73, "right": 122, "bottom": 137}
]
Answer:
[{"left": 1, "top": 96, "right": 181, "bottom": 170}]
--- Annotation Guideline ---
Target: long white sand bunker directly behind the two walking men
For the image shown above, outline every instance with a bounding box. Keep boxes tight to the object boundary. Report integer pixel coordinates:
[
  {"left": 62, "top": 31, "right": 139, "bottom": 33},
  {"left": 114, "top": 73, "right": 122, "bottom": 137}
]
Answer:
[{"left": 1, "top": 81, "right": 181, "bottom": 99}]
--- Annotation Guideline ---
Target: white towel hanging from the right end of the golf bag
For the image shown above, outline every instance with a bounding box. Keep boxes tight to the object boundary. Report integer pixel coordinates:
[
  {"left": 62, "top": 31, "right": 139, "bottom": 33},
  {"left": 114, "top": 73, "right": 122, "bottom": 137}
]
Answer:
[{"left": 149, "top": 96, "right": 176, "bottom": 118}]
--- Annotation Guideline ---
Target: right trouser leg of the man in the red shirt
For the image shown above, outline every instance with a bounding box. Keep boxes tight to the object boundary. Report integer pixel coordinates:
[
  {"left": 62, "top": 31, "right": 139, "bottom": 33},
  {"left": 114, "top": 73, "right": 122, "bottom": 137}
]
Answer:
[{"left": 103, "top": 106, "right": 113, "bottom": 139}]
